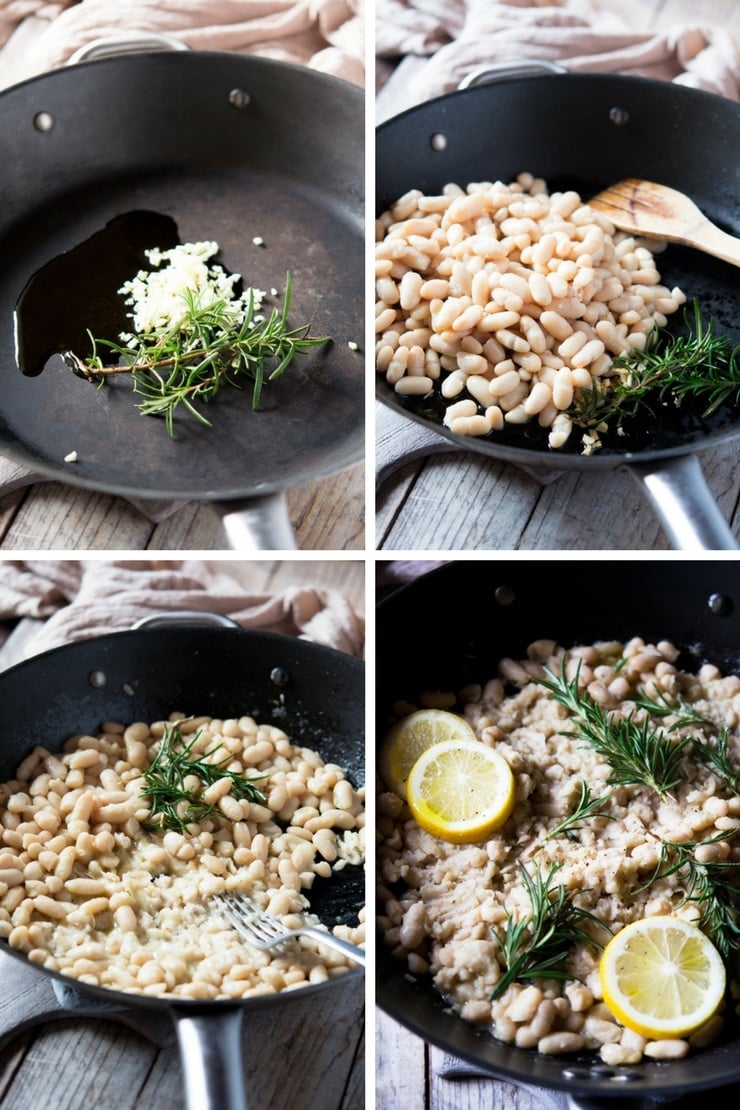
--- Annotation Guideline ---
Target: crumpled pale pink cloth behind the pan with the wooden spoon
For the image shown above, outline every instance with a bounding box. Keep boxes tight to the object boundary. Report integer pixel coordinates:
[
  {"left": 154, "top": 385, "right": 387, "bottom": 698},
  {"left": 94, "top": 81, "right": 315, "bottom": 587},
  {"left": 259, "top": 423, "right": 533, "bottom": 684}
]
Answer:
[{"left": 376, "top": 0, "right": 740, "bottom": 102}]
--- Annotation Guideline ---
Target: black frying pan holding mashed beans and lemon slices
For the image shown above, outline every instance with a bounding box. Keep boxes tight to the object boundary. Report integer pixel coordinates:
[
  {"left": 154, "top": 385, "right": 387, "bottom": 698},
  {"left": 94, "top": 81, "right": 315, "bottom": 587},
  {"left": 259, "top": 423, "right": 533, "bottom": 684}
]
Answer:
[{"left": 376, "top": 559, "right": 740, "bottom": 1104}]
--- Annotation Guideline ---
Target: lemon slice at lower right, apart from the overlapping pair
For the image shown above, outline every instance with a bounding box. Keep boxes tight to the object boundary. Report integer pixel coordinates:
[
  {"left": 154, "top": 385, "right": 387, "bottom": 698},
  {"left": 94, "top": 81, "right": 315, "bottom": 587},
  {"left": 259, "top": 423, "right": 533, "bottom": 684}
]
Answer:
[{"left": 599, "top": 917, "right": 726, "bottom": 1039}]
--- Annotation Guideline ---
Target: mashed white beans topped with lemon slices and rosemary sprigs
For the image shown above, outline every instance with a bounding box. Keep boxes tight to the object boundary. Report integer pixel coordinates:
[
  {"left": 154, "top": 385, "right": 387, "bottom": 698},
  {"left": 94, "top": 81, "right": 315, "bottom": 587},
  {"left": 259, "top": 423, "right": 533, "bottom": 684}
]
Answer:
[{"left": 378, "top": 638, "right": 740, "bottom": 1064}]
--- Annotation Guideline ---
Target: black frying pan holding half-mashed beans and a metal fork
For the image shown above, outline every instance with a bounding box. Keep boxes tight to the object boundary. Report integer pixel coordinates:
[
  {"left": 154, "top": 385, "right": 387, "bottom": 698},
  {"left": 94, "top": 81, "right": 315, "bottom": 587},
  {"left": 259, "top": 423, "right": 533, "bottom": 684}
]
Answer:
[{"left": 0, "top": 616, "right": 365, "bottom": 1110}]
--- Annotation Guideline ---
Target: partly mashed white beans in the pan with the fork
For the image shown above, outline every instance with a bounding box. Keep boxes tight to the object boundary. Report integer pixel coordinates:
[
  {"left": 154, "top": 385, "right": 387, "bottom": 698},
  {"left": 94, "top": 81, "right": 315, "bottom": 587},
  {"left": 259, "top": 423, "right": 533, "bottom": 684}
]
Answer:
[{"left": 0, "top": 714, "right": 365, "bottom": 999}]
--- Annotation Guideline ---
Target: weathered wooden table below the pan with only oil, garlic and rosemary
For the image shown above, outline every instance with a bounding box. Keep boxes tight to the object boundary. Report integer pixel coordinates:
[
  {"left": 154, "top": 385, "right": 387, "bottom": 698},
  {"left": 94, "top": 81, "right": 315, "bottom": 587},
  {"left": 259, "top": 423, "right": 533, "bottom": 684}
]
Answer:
[{"left": 0, "top": 465, "right": 365, "bottom": 552}]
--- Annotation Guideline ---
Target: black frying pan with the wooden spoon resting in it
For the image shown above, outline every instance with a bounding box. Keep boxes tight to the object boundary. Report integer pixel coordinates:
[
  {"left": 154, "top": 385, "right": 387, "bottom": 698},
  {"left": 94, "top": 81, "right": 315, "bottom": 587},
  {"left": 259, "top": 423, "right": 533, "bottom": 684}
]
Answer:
[{"left": 376, "top": 73, "right": 740, "bottom": 548}]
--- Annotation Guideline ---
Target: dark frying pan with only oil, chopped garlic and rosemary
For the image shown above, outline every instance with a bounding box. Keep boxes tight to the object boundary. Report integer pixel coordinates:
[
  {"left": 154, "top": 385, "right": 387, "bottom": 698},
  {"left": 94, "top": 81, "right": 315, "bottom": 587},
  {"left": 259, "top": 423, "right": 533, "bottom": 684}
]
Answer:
[{"left": 0, "top": 51, "right": 364, "bottom": 548}]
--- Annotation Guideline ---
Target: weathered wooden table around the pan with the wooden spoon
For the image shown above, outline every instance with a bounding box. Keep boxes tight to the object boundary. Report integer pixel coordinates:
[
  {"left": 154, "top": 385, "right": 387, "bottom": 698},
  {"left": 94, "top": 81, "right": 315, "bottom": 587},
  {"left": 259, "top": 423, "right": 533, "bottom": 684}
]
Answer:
[{"left": 375, "top": 0, "right": 740, "bottom": 551}]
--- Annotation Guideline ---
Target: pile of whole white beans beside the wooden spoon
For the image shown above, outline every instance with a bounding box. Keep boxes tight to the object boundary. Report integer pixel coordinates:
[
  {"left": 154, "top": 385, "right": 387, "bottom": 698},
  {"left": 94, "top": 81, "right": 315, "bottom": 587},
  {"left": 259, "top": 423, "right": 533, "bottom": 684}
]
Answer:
[{"left": 375, "top": 173, "right": 686, "bottom": 451}]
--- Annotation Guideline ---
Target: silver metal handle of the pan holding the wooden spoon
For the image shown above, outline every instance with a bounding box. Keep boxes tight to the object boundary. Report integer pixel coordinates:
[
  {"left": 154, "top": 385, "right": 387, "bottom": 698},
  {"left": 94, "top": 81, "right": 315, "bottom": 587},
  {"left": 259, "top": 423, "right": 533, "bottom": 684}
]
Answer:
[{"left": 628, "top": 455, "right": 738, "bottom": 551}]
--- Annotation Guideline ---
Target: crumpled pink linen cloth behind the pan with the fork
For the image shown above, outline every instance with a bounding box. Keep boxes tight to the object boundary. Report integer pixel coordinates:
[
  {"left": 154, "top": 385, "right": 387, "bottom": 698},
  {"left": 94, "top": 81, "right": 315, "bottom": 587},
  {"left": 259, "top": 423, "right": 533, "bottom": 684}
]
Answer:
[{"left": 0, "top": 559, "right": 365, "bottom": 657}]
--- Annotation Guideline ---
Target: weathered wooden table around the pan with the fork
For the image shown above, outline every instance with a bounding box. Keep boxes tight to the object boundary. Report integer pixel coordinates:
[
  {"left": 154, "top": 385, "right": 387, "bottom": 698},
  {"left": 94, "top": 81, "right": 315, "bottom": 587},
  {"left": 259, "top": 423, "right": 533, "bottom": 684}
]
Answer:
[{"left": 0, "top": 561, "right": 365, "bottom": 1110}]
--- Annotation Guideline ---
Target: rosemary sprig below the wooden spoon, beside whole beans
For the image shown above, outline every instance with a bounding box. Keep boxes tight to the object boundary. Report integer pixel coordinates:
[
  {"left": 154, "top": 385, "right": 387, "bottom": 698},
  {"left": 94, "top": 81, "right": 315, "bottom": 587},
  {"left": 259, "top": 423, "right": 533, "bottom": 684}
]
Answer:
[{"left": 569, "top": 301, "right": 740, "bottom": 431}]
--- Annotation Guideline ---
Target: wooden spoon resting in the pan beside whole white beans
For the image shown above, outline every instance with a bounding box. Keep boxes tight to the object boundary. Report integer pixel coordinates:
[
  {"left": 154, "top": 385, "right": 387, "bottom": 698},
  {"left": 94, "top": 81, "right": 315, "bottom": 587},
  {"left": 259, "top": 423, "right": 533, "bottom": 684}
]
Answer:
[{"left": 589, "top": 178, "right": 740, "bottom": 266}]
